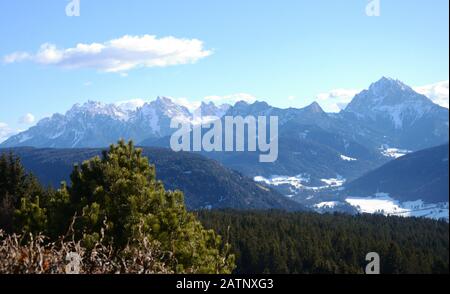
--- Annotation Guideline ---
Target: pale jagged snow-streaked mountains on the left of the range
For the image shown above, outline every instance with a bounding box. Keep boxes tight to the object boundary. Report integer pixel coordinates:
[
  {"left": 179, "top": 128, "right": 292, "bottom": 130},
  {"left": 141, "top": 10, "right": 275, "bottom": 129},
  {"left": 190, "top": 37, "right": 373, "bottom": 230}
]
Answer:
[{"left": 1, "top": 97, "right": 227, "bottom": 148}]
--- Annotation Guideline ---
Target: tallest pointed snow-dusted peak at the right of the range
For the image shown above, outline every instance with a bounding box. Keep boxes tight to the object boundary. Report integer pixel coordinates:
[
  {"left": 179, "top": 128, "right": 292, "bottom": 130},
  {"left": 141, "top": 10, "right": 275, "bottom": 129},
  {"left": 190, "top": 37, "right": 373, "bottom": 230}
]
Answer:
[{"left": 340, "top": 77, "right": 449, "bottom": 150}]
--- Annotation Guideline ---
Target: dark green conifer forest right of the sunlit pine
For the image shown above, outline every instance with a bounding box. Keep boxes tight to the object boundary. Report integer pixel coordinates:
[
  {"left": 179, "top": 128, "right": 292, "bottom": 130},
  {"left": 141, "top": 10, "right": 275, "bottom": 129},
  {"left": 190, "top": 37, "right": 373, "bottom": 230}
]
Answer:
[{"left": 197, "top": 210, "right": 449, "bottom": 274}]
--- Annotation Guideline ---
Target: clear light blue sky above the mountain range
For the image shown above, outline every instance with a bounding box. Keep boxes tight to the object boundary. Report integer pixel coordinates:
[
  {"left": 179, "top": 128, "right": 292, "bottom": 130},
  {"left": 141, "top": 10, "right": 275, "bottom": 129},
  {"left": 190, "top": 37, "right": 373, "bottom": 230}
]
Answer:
[{"left": 0, "top": 0, "right": 449, "bottom": 137}]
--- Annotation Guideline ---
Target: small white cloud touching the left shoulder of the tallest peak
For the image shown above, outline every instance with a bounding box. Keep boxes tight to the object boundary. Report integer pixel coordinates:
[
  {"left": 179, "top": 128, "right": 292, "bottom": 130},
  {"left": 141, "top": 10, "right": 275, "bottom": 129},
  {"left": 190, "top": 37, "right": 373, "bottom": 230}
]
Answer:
[{"left": 316, "top": 89, "right": 360, "bottom": 112}]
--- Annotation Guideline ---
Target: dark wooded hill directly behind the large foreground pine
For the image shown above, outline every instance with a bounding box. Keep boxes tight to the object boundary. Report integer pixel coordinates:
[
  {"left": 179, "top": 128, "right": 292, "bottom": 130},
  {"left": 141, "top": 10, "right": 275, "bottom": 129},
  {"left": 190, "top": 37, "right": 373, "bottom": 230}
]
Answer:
[{"left": 0, "top": 147, "right": 303, "bottom": 210}]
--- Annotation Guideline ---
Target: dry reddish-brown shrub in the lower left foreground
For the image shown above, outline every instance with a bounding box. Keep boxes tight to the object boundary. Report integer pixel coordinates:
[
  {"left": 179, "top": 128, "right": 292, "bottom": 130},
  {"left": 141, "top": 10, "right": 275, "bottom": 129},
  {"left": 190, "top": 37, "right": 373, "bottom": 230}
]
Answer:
[{"left": 0, "top": 218, "right": 173, "bottom": 274}]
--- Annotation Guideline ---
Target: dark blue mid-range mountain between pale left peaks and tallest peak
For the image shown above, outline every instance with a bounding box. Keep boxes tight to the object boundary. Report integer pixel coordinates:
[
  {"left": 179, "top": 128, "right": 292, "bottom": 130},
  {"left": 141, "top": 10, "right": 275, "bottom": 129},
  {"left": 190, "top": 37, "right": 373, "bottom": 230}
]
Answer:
[{"left": 200, "top": 102, "right": 385, "bottom": 185}]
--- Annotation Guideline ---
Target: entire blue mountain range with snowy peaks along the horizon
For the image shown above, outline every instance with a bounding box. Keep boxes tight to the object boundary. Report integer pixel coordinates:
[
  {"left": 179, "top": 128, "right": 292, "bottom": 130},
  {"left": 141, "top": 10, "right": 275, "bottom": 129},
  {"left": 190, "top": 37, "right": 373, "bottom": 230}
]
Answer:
[{"left": 0, "top": 78, "right": 448, "bottom": 170}]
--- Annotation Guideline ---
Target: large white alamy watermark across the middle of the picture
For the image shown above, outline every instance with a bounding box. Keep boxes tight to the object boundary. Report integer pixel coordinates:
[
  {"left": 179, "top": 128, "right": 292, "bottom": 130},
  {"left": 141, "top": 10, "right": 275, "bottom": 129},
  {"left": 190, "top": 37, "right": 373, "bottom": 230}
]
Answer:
[{"left": 170, "top": 116, "right": 278, "bottom": 163}]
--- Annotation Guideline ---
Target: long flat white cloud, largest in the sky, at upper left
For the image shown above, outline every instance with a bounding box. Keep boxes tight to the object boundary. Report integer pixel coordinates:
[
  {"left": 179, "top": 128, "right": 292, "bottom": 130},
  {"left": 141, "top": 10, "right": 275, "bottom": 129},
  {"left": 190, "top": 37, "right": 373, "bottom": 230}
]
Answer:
[{"left": 3, "top": 35, "right": 212, "bottom": 73}]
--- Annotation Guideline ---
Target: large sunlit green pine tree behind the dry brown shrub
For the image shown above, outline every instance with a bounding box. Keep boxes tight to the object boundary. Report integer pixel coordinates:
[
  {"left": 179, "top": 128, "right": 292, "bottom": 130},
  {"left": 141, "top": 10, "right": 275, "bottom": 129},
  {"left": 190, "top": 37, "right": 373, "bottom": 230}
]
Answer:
[{"left": 57, "top": 140, "right": 234, "bottom": 273}]
